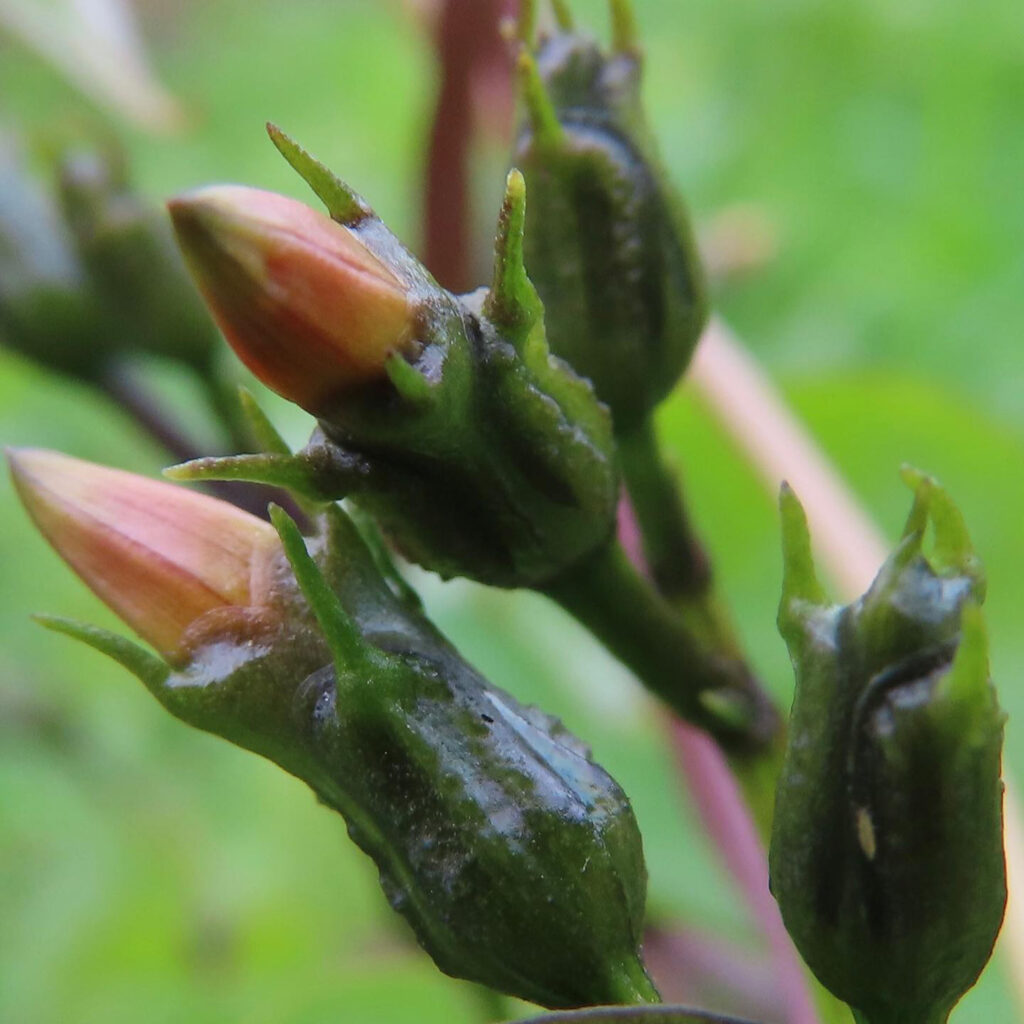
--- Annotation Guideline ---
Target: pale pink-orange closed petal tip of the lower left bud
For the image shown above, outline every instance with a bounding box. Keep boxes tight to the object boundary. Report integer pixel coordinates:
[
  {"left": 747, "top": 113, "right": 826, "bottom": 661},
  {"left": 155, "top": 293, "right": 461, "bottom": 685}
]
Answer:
[{"left": 8, "top": 449, "right": 280, "bottom": 665}]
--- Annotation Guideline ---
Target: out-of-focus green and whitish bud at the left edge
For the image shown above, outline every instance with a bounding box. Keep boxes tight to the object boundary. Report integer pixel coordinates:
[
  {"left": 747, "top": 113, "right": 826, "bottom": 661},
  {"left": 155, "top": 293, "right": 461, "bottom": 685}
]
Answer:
[{"left": 0, "top": 139, "right": 220, "bottom": 382}]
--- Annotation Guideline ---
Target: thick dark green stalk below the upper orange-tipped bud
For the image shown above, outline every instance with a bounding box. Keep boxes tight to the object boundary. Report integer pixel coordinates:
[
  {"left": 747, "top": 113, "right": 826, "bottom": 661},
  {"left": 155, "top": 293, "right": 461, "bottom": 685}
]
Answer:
[{"left": 547, "top": 543, "right": 783, "bottom": 835}]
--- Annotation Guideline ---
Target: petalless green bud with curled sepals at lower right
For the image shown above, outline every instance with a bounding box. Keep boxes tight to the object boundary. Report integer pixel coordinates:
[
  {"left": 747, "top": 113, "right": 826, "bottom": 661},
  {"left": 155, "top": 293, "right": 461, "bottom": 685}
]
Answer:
[{"left": 770, "top": 470, "right": 1007, "bottom": 1024}]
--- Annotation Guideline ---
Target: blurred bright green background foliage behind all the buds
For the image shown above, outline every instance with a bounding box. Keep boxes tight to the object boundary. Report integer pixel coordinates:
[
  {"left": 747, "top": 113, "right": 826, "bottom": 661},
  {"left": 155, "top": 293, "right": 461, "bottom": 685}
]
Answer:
[{"left": 0, "top": 0, "right": 1024, "bottom": 1024}]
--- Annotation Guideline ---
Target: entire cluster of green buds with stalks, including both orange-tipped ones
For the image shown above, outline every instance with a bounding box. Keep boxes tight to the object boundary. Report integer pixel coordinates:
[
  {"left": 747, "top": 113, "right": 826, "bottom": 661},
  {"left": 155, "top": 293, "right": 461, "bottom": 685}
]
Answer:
[{"left": 0, "top": 0, "right": 1007, "bottom": 1024}]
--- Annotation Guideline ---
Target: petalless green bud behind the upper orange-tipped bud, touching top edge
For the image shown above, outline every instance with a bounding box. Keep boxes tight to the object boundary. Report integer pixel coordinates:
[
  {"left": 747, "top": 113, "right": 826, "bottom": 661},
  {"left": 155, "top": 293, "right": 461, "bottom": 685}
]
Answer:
[{"left": 514, "top": 0, "right": 708, "bottom": 433}]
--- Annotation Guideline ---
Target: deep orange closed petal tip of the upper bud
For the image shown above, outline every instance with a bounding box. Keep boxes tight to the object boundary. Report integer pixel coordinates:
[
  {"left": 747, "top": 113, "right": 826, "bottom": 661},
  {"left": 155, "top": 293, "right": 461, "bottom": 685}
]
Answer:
[{"left": 169, "top": 185, "right": 416, "bottom": 413}]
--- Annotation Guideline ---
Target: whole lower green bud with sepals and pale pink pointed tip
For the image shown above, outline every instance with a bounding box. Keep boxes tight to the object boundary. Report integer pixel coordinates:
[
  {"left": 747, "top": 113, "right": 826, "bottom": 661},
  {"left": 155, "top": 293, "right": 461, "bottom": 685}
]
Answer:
[{"left": 11, "top": 452, "right": 656, "bottom": 1008}]
